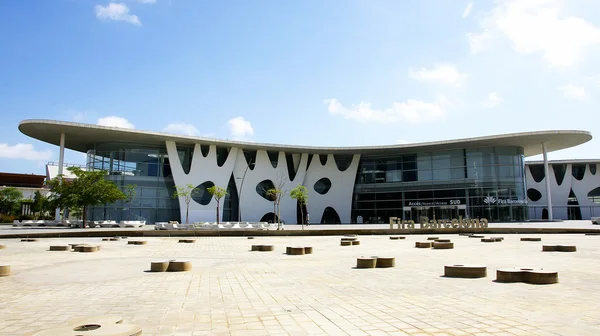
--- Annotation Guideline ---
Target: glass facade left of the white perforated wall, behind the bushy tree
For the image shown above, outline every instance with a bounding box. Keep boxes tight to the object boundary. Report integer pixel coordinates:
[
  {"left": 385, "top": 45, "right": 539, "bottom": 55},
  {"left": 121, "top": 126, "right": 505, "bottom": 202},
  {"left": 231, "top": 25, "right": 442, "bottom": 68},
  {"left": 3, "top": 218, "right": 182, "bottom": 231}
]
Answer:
[{"left": 87, "top": 143, "right": 180, "bottom": 223}]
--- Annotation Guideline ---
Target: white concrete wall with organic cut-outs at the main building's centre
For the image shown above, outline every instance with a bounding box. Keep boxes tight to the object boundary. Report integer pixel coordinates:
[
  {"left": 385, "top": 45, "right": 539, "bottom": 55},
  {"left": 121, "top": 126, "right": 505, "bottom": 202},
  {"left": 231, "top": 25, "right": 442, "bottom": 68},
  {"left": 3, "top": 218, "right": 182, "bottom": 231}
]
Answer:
[{"left": 166, "top": 141, "right": 360, "bottom": 224}]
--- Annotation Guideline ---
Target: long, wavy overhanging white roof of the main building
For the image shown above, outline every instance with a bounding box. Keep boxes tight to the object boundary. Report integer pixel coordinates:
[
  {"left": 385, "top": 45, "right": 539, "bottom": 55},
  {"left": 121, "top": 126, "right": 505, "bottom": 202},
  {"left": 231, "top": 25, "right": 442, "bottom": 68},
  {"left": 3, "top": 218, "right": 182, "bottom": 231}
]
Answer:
[{"left": 19, "top": 119, "right": 592, "bottom": 156}]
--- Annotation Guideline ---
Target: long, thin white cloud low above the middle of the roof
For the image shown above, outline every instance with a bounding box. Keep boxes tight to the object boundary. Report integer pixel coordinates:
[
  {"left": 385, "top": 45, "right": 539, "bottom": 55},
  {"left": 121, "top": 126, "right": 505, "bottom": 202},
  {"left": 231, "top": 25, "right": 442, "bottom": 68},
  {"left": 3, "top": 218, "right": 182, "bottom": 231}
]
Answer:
[{"left": 324, "top": 97, "right": 450, "bottom": 124}]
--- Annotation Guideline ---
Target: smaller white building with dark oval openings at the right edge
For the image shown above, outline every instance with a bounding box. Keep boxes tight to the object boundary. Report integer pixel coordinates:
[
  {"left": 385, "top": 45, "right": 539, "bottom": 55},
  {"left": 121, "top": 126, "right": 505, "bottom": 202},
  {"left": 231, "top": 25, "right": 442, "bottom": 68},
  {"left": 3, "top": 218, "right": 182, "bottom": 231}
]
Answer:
[{"left": 525, "top": 160, "right": 600, "bottom": 220}]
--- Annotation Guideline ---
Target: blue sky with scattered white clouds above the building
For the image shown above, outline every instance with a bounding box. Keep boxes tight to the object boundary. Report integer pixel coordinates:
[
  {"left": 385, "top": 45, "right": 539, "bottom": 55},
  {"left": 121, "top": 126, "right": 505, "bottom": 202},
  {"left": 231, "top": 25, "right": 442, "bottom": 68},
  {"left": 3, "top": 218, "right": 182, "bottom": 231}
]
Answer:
[{"left": 0, "top": 0, "right": 600, "bottom": 174}]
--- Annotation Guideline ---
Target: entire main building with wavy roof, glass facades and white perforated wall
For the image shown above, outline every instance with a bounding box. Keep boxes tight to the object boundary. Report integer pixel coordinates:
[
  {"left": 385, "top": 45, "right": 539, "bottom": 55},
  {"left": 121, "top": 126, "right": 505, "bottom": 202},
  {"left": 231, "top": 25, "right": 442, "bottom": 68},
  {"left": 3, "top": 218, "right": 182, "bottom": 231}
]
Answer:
[{"left": 19, "top": 120, "right": 591, "bottom": 224}]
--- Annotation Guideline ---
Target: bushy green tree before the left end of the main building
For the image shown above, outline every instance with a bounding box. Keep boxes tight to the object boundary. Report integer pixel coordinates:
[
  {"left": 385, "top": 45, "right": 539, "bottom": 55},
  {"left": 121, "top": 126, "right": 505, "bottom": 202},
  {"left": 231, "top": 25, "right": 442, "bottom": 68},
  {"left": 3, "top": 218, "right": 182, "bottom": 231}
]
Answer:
[{"left": 48, "top": 167, "right": 126, "bottom": 227}]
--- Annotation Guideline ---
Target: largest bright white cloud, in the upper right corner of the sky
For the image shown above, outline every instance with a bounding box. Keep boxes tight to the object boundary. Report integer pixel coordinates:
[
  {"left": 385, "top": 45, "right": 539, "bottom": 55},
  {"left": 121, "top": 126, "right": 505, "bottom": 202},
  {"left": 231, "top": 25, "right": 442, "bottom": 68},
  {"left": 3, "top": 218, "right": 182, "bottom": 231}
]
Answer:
[{"left": 467, "top": 0, "right": 600, "bottom": 67}]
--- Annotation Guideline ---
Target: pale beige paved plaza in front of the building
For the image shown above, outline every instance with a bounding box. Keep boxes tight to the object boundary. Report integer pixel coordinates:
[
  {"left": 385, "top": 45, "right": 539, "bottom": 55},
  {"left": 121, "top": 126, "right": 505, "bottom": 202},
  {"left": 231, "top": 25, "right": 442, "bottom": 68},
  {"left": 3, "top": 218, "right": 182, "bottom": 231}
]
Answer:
[{"left": 0, "top": 234, "right": 600, "bottom": 335}]
